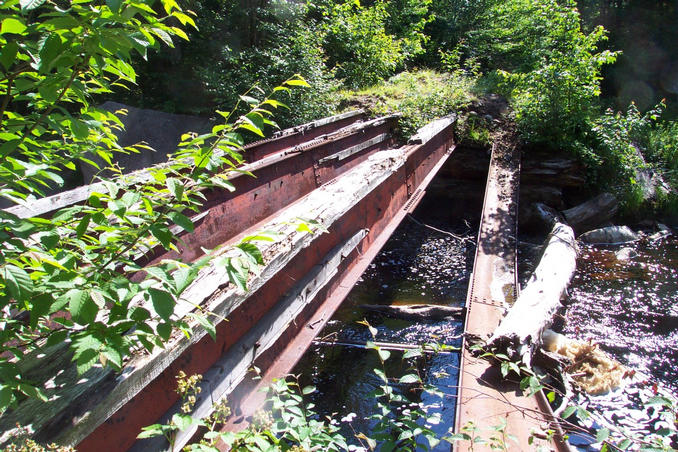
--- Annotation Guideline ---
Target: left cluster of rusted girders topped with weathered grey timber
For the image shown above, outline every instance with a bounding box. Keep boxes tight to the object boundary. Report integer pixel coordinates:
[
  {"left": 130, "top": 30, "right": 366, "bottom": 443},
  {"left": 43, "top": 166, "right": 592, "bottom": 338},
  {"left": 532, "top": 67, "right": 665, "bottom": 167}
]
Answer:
[{"left": 0, "top": 111, "right": 454, "bottom": 451}]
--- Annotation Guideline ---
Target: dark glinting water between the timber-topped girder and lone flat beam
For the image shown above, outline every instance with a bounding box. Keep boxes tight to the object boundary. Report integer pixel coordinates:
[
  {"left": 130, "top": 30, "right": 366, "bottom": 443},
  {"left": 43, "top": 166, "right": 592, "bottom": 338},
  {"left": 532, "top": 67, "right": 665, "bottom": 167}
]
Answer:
[{"left": 294, "top": 220, "right": 474, "bottom": 451}]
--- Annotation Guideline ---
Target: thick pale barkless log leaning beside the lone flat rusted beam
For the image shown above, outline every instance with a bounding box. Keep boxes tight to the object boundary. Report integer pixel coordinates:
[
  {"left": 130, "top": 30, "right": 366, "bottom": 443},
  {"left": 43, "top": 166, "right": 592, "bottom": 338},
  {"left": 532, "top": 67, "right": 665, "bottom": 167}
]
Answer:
[{"left": 488, "top": 222, "right": 577, "bottom": 367}]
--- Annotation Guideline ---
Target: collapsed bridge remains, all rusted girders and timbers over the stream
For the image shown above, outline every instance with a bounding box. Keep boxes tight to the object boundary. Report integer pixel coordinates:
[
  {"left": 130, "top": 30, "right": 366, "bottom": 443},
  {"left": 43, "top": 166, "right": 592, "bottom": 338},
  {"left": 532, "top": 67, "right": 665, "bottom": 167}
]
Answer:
[{"left": 0, "top": 111, "right": 572, "bottom": 451}]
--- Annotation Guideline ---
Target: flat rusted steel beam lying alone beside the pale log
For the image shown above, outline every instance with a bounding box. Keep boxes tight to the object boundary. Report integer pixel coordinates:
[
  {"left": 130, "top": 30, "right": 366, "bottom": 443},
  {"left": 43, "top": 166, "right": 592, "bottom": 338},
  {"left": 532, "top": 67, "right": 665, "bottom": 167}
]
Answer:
[{"left": 452, "top": 143, "right": 568, "bottom": 451}]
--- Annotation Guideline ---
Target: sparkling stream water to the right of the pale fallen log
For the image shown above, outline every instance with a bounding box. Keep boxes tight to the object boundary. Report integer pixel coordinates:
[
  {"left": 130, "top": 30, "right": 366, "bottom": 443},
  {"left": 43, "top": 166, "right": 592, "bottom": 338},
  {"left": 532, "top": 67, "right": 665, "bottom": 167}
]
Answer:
[{"left": 548, "top": 231, "right": 678, "bottom": 451}]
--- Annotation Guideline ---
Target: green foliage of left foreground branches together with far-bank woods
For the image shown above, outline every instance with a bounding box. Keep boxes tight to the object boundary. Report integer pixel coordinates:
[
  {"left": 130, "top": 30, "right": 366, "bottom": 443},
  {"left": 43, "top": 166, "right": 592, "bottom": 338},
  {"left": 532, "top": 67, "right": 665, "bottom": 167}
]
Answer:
[{"left": 0, "top": 0, "right": 678, "bottom": 450}]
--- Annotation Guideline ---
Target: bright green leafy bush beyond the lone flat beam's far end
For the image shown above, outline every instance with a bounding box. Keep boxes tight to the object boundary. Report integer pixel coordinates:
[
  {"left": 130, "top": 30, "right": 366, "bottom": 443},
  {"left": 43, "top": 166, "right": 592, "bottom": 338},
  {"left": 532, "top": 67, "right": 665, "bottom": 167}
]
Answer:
[{"left": 480, "top": 0, "right": 616, "bottom": 148}]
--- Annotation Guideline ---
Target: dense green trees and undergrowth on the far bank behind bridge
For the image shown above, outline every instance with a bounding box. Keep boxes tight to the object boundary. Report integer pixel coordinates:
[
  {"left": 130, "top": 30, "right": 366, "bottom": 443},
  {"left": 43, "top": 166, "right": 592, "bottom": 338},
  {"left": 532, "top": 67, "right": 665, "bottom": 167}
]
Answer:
[{"left": 128, "top": 0, "right": 678, "bottom": 216}]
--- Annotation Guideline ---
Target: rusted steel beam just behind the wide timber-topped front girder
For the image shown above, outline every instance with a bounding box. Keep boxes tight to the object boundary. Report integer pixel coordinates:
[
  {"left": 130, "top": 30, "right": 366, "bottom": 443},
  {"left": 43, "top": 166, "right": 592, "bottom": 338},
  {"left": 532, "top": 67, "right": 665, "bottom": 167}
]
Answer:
[{"left": 138, "top": 116, "right": 397, "bottom": 265}]
